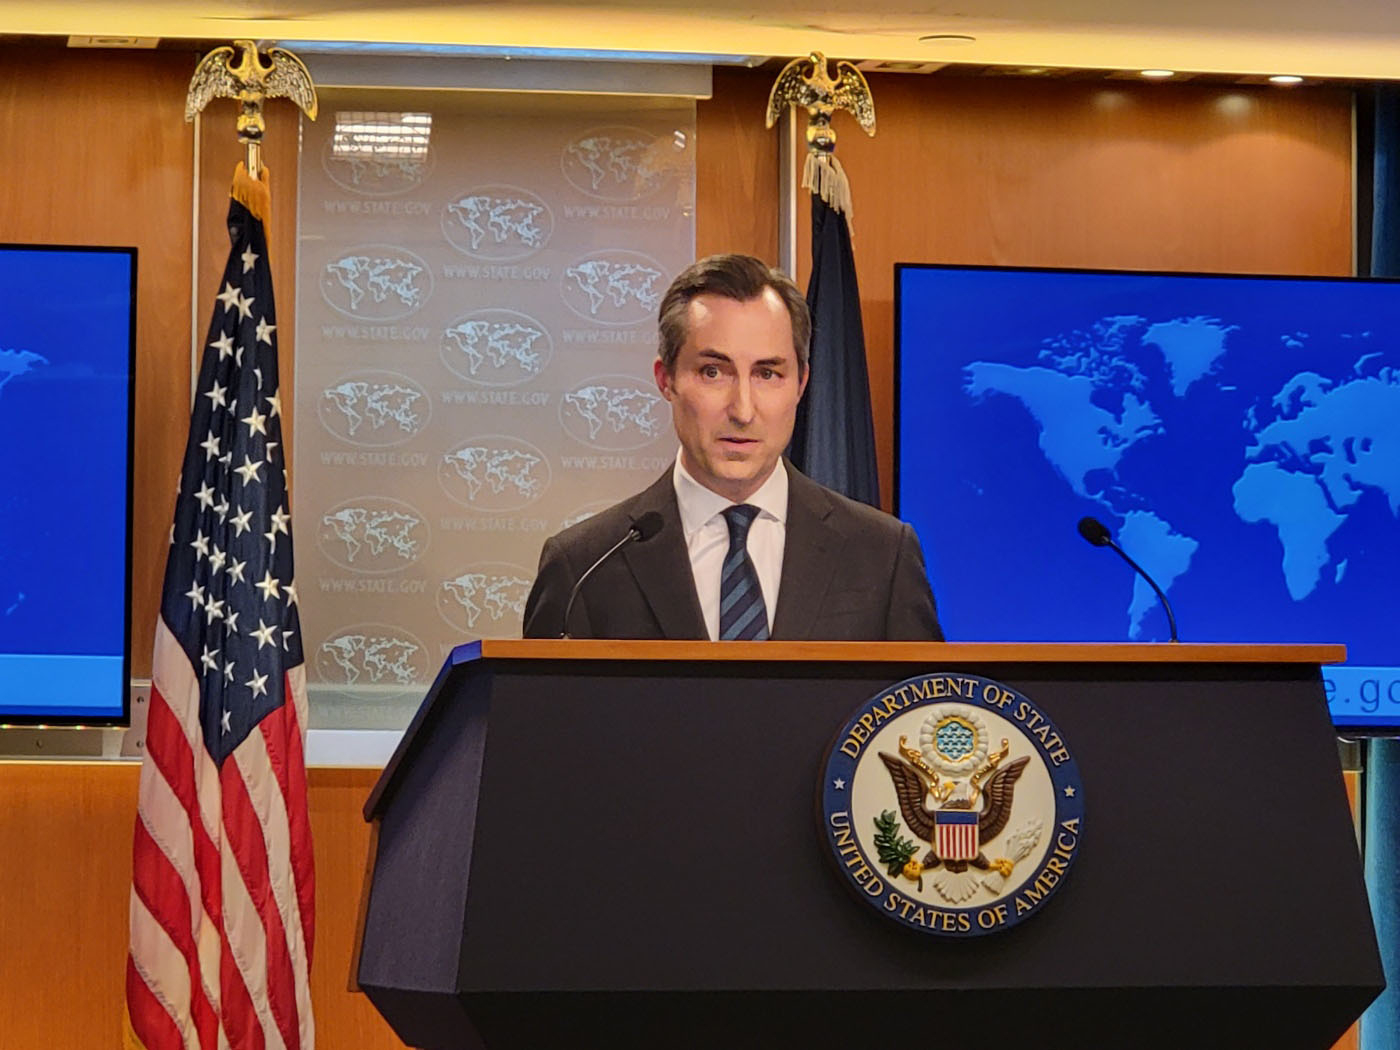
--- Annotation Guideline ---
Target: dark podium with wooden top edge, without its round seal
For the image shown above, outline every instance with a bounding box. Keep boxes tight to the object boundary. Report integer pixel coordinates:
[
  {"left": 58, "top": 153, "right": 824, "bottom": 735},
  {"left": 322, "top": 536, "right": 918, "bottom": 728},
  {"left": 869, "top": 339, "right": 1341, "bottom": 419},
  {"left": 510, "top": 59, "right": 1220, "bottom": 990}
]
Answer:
[{"left": 356, "top": 641, "right": 1383, "bottom": 1050}]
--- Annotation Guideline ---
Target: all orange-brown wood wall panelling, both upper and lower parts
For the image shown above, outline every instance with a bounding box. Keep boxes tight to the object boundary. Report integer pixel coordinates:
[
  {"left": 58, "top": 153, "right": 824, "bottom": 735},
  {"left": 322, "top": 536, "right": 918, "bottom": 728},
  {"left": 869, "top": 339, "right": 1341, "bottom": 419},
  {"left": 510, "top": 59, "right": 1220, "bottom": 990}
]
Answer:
[{"left": 0, "top": 48, "right": 1351, "bottom": 1049}]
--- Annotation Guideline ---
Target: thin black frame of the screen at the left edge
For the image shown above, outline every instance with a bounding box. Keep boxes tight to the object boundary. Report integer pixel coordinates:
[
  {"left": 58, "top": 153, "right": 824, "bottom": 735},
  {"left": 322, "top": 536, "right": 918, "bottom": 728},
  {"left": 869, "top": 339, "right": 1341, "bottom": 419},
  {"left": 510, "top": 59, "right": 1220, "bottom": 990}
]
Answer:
[{"left": 0, "top": 241, "right": 139, "bottom": 728}]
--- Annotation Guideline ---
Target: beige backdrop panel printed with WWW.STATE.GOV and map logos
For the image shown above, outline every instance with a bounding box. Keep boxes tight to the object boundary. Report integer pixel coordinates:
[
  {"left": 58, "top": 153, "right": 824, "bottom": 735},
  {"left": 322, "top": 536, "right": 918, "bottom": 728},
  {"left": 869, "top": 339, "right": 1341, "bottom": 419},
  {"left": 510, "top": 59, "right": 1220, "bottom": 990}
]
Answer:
[{"left": 294, "top": 94, "right": 694, "bottom": 725}]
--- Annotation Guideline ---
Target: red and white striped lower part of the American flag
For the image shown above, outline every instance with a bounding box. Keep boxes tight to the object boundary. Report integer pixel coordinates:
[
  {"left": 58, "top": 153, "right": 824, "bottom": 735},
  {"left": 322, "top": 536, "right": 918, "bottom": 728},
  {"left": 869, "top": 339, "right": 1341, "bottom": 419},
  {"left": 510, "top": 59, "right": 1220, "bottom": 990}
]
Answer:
[{"left": 126, "top": 622, "right": 315, "bottom": 1050}]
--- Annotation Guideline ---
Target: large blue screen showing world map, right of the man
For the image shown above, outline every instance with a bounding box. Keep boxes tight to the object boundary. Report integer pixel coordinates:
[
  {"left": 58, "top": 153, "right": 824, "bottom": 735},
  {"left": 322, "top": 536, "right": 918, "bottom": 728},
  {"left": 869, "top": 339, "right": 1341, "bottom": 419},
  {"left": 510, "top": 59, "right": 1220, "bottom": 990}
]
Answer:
[{"left": 896, "top": 266, "right": 1400, "bottom": 729}]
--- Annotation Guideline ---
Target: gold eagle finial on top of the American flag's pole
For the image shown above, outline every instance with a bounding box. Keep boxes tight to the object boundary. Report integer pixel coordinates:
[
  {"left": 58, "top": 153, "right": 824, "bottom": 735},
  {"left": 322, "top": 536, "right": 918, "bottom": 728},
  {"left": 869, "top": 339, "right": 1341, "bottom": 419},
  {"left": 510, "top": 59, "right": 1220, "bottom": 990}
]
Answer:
[{"left": 185, "top": 41, "right": 316, "bottom": 179}]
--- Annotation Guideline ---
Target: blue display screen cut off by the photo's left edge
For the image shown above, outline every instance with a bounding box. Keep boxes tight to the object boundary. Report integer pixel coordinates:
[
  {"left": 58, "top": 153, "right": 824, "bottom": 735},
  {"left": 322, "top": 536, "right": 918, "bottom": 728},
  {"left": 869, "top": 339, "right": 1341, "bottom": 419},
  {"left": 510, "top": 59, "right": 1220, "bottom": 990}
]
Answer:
[{"left": 0, "top": 245, "right": 136, "bottom": 724}]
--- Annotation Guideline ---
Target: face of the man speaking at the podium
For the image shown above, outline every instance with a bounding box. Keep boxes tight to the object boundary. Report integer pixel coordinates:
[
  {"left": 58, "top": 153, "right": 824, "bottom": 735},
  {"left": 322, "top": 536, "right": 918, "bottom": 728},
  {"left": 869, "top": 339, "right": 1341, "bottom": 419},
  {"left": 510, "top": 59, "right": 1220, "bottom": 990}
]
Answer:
[{"left": 655, "top": 288, "right": 806, "bottom": 503}]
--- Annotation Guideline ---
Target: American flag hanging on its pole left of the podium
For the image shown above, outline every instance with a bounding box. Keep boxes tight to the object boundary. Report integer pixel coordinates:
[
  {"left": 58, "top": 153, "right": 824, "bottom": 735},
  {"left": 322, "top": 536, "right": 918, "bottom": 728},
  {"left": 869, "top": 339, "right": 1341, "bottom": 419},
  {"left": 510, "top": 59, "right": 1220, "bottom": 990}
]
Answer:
[{"left": 126, "top": 169, "right": 315, "bottom": 1050}]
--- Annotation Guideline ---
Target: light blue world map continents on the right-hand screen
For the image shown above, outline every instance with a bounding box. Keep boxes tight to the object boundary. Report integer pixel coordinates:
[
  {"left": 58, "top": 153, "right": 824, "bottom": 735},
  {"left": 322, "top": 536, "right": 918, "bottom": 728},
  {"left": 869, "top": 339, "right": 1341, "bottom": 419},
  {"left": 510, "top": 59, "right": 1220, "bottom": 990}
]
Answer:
[{"left": 963, "top": 312, "right": 1400, "bottom": 638}]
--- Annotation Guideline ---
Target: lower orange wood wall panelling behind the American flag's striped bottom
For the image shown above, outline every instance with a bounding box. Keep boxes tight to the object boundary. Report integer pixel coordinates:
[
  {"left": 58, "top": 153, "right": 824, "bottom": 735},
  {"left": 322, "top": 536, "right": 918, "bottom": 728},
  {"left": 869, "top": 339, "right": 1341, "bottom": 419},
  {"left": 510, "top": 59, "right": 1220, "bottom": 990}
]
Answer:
[{"left": 0, "top": 762, "right": 402, "bottom": 1050}]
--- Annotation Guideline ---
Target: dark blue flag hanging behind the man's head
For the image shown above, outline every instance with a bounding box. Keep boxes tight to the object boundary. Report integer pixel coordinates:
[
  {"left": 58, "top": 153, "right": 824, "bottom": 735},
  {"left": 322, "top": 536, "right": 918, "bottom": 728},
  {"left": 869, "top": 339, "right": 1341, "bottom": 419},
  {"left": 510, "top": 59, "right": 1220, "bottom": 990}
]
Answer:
[{"left": 788, "top": 193, "right": 879, "bottom": 507}]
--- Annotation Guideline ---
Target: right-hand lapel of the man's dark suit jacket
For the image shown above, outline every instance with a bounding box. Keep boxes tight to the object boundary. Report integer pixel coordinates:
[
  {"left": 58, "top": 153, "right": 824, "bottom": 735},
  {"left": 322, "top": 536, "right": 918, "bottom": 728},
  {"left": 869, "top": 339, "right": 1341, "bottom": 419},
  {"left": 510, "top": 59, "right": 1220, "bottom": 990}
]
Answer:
[{"left": 771, "top": 461, "right": 846, "bottom": 641}]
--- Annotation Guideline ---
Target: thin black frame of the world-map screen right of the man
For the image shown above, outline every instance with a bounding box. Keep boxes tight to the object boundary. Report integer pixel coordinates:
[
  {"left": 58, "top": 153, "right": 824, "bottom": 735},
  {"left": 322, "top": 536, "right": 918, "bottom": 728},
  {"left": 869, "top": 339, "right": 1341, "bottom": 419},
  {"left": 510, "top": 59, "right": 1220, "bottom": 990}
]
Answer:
[{"left": 890, "top": 262, "right": 1400, "bottom": 738}]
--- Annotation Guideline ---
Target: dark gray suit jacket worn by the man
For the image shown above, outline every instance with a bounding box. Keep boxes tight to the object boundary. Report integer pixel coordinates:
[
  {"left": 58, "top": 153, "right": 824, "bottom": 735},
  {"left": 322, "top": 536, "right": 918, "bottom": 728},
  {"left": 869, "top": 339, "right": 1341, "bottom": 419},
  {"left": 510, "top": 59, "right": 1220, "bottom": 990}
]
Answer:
[{"left": 525, "top": 461, "right": 944, "bottom": 641}]
